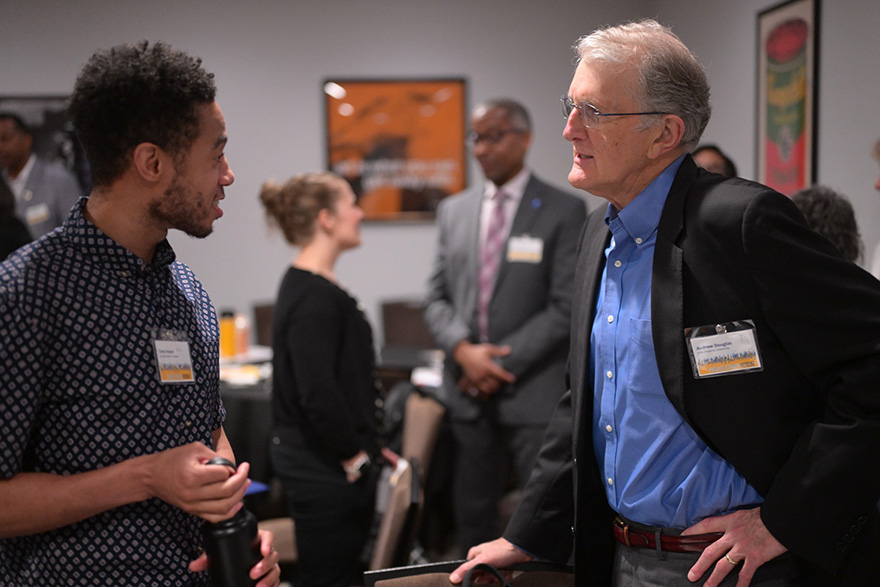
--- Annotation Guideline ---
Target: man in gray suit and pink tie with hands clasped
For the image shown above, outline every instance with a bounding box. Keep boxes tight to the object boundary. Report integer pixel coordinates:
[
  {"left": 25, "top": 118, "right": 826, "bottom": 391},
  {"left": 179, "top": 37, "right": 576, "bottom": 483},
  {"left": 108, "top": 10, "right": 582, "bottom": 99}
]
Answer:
[{"left": 425, "top": 100, "right": 586, "bottom": 552}]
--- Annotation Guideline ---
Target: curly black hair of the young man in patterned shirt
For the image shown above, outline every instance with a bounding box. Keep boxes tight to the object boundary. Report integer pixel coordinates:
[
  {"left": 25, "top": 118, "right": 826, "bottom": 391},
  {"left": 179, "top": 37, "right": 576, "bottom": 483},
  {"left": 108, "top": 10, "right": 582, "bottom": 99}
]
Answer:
[{"left": 68, "top": 41, "right": 217, "bottom": 187}]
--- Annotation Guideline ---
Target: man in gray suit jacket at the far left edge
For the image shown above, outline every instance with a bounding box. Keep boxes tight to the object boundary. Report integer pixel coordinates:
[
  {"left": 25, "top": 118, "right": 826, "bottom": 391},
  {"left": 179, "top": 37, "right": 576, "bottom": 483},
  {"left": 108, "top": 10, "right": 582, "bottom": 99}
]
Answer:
[{"left": 0, "top": 112, "right": 83, "bottom": 239}]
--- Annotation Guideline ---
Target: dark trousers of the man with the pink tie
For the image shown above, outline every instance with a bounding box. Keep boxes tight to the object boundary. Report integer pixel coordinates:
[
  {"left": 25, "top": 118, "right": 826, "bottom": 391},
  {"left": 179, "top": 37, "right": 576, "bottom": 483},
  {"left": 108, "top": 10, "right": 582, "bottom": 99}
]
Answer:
[{"left": 451, "top": 417, "right": 546, "bottom": 556}]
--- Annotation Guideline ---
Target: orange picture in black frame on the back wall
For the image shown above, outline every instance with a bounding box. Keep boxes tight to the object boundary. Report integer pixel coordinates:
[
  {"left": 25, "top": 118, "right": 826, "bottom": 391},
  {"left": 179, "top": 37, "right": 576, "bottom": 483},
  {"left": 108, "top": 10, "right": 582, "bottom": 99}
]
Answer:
[{"left": 322, "top": 78, "right": 467, "bottom": 222}]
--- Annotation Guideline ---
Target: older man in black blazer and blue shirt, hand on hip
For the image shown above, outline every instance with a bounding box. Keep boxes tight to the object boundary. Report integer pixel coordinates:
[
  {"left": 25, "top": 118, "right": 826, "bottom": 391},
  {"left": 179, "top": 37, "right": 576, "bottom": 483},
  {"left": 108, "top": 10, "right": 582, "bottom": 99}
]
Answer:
[{"left": 451, "top": 21, "right": 880, "bottom": 587}]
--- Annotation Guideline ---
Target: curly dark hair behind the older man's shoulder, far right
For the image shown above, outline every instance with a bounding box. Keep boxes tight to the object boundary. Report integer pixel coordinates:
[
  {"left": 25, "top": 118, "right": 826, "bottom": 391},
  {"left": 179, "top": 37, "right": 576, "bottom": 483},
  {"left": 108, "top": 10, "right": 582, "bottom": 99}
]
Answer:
[{"left": 791, "top": 185, "right": 862, "bottom": 262}]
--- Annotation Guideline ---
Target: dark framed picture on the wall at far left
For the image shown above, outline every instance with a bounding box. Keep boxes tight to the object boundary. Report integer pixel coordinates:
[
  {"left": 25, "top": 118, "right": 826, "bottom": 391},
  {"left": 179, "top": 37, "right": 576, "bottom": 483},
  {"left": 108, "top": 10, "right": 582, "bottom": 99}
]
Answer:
[{"left": 0, "top": 95, "right": 91, "bottom": 194}]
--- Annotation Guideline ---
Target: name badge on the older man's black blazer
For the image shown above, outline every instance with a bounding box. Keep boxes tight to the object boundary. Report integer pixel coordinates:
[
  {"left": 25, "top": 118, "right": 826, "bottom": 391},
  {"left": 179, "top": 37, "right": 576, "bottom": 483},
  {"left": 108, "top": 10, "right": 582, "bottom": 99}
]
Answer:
[{"left": 684, "top": 320, "right": 764, "bottom": 379}]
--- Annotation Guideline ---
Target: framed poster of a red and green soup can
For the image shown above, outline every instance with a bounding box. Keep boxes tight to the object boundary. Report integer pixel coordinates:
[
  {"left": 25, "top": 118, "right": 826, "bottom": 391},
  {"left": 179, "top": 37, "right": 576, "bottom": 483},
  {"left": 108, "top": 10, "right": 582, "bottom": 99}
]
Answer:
[{"left": 755, "top": 0, "right": 820, "bottom": 196}]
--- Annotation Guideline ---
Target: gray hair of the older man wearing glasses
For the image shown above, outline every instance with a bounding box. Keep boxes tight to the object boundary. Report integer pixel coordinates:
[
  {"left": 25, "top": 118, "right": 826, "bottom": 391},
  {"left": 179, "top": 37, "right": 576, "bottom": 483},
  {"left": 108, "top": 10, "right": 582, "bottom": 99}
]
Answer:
[{"left": 575, "top": 20, "right": 712, "bottom": 148}]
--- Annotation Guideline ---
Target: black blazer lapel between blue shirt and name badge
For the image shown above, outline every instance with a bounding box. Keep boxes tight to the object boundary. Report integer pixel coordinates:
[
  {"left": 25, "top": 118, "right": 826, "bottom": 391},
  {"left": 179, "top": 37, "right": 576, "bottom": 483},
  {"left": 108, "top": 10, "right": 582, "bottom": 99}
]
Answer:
[{"left": 651, "top": 156, "right": 697, "bottom": 425}]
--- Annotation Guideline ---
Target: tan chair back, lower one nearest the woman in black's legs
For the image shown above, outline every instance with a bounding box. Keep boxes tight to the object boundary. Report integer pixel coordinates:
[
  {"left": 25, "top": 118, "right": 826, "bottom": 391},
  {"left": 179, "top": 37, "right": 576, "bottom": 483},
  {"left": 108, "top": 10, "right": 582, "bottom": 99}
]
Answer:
[{"left": 370, "top": 460, "right": 423, "bottom": 569}]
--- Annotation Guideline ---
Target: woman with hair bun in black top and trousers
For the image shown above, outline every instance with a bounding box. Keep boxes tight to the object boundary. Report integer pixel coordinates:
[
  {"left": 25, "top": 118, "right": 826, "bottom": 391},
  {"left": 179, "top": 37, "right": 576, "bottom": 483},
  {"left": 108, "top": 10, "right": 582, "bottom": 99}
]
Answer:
[{"left": 260, "top": 172, "right": 394, "bottom": 587}]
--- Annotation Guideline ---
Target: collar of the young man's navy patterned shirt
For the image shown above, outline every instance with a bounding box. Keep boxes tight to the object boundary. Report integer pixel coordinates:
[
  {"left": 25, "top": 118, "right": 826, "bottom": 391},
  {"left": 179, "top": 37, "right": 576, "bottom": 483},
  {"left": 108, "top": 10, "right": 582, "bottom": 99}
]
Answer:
[{"left": 62, "top": 197, "right": 177, "bottom": 277}]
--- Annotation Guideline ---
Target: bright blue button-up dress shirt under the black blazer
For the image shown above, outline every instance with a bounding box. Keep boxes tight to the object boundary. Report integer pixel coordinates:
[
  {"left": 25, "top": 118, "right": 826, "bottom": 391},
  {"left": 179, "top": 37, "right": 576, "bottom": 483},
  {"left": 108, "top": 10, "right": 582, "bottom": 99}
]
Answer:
[{"left": 590, "top": 157, "right": 762, "bottom": 529}]
